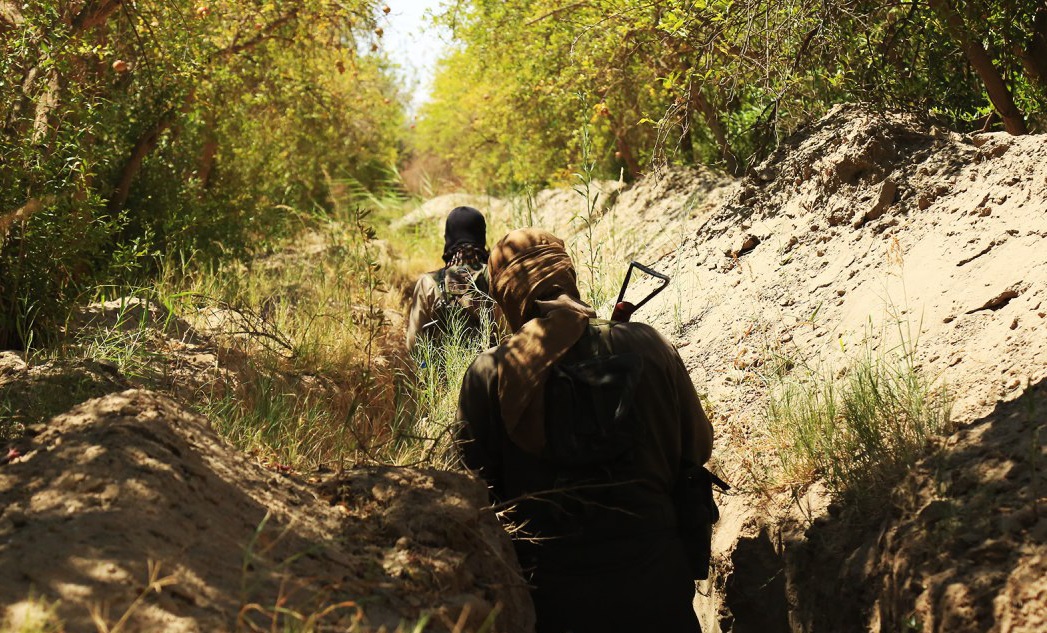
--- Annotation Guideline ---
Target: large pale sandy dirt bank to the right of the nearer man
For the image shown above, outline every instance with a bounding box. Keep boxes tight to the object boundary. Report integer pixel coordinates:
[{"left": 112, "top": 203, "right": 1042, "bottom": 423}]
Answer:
[{"left": 623, "top": 107, "right": 1047, "bottom": 632}]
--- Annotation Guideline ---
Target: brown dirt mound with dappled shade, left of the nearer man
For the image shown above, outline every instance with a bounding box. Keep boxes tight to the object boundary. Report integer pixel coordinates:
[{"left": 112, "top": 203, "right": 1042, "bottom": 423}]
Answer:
[{"left": 0, "top": 390, "right": 531, "bottom": 631}]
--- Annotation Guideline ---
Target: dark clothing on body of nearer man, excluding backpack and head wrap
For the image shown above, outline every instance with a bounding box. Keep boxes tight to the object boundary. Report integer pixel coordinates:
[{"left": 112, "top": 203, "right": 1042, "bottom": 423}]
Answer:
[{"left": 460, "top": 323, "right": 712, "bottom": 633}]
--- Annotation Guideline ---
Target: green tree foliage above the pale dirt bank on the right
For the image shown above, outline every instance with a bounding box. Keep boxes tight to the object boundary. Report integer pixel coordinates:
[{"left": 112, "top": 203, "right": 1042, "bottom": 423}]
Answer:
[{"left": 416, "top": 0, "right": 1047, "bottom": 188}]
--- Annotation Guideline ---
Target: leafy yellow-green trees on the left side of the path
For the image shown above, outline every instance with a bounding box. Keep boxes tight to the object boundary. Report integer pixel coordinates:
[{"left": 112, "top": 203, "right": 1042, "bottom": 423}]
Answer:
[{"left": 0, "top": 0, "right": 403, "bottom": 347}]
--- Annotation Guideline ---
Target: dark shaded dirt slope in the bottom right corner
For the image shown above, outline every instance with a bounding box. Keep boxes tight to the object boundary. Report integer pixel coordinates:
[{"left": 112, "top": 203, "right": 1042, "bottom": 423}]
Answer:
[{"left": 783, "top": 381, "right": 1047, "bottom": 633}]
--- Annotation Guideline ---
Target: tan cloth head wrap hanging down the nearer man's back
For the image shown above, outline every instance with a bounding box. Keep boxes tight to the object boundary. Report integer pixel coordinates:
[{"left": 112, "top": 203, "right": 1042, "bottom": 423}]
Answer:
[{"left": 488, "top": 229, "right": 596, "bottom": 454}]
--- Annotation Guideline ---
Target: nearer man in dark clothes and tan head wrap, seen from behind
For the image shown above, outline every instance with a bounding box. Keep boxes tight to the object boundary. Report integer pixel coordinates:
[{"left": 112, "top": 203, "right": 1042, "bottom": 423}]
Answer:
[{"left": 458, "top": 229, "right": 712, "bottom": 633}]
